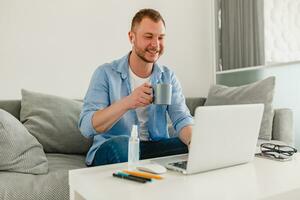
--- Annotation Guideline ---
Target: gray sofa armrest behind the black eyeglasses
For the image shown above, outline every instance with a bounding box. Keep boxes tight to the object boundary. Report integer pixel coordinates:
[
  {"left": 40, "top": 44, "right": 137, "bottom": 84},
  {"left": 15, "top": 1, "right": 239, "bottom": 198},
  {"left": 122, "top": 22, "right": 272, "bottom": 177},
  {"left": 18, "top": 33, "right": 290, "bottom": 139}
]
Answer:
[{"left": 272, "top": 108, "right": 294, "bottom": 145}]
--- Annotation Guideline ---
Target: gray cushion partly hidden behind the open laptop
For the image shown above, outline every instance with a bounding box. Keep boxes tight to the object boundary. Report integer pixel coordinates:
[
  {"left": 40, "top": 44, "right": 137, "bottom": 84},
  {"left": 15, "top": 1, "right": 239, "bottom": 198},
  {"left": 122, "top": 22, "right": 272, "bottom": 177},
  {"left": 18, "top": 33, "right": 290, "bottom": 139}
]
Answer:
[{"left": 205, "top": 77, "right": 275, "bottom": 140}]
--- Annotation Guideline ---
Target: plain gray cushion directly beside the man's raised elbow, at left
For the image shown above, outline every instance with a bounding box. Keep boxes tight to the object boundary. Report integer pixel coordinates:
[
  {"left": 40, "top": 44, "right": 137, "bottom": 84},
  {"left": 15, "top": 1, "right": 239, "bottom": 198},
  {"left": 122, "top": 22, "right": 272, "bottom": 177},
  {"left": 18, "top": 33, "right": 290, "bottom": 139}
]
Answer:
[{"left": 20, "top": 90, "right": 91, "bottom": 154}]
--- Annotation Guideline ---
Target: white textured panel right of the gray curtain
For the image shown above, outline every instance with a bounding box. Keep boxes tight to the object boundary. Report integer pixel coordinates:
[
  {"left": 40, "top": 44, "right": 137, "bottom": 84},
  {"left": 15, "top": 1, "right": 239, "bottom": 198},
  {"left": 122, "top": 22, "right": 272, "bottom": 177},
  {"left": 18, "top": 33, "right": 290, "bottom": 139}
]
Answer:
[{"left": 264, "top": 0, "right": 300, "bottom": 64}]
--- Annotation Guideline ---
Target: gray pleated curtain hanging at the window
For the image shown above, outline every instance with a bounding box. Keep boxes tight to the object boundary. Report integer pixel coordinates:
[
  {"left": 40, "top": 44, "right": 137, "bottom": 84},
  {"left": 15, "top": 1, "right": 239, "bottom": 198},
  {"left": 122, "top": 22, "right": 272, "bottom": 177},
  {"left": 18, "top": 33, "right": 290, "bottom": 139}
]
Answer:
[{"left": 219, "top": 0, "right": 265, "bottom": 70}]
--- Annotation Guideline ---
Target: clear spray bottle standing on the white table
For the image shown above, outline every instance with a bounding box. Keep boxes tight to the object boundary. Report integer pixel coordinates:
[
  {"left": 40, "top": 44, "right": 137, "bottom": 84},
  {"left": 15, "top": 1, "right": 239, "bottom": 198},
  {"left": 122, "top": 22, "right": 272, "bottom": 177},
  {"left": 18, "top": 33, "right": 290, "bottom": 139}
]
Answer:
[{"left": 128, "top": 125, "right": 140, "bottom": 168}]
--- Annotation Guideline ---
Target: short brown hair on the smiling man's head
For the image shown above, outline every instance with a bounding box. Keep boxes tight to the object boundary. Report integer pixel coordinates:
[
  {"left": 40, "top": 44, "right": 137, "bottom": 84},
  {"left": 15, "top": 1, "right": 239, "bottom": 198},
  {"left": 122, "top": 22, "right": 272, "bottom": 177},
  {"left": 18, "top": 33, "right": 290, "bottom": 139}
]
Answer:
[{"left": 131, "top": 8, "right": 166, "bottom": 31}]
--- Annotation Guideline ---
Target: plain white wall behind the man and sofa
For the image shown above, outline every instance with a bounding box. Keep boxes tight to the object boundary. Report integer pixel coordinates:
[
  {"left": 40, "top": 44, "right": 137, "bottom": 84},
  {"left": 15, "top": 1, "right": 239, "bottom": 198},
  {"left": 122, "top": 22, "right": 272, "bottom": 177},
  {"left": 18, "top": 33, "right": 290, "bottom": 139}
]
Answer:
[{"left": 0, "top": 0, "right": 214, "bottom": 99}]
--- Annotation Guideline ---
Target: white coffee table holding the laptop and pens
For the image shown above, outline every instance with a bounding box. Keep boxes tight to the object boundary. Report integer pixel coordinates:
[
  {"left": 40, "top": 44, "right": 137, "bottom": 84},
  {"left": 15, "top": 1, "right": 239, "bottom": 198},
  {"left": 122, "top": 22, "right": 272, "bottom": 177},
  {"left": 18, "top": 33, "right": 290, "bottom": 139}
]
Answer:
[{"left": 69, "top": 153, "right": 300, "bottom": 200}]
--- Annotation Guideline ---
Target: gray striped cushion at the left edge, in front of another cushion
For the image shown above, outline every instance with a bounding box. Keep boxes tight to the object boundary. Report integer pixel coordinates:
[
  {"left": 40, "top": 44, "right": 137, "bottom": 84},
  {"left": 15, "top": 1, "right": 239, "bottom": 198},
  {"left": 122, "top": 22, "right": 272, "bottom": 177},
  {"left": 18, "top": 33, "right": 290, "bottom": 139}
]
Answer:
[{"left": 0, "top": 109, "right": 48, "bottom": 174}]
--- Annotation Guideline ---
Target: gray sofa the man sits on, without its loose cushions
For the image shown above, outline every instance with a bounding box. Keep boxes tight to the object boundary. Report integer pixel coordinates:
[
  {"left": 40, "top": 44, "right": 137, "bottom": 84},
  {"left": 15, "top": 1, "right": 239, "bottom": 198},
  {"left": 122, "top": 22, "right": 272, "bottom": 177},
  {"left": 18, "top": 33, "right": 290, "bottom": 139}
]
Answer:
[{"left": 0, "top": 98, "right": 293, "bottom": 200}]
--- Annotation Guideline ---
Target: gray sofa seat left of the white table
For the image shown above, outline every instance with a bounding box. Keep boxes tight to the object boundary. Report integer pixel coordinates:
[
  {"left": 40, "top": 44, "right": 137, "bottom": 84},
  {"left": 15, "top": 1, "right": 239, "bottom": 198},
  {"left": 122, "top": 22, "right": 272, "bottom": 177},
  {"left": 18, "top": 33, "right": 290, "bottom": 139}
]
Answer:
[{"left": 0, "top": 154, "right": 85, "bottom": 200}]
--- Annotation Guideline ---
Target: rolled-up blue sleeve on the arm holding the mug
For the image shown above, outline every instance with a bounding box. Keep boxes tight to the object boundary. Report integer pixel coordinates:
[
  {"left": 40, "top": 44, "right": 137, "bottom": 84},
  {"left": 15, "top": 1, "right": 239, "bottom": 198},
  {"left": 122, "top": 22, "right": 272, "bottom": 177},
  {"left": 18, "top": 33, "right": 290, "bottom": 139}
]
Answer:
[{"left": 78, "top": 66, "right": 109, "bottom": 138}]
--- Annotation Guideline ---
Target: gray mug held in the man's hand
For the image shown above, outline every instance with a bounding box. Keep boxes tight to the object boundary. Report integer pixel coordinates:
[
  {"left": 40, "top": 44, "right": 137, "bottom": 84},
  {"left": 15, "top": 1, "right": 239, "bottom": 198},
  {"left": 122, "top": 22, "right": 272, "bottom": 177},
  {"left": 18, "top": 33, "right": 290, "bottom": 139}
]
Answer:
[{"left": 152, "top": 83, "right": 172, "bottom": 105}]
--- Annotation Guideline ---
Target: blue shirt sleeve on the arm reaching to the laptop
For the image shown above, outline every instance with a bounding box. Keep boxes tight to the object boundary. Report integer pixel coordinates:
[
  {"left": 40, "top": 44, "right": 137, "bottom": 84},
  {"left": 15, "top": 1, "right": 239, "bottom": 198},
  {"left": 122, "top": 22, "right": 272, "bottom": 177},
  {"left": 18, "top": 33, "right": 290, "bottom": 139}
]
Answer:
[{"left": 168, "top": 73, "right": 194, "bottom": 134}]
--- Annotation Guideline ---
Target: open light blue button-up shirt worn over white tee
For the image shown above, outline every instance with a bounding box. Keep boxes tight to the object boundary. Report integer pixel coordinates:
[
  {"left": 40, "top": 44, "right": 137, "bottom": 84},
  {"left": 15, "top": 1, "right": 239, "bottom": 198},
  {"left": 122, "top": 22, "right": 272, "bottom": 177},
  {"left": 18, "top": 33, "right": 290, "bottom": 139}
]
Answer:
[{"left": 78, "top": 54, "right": 193, "bottom": 165}]
